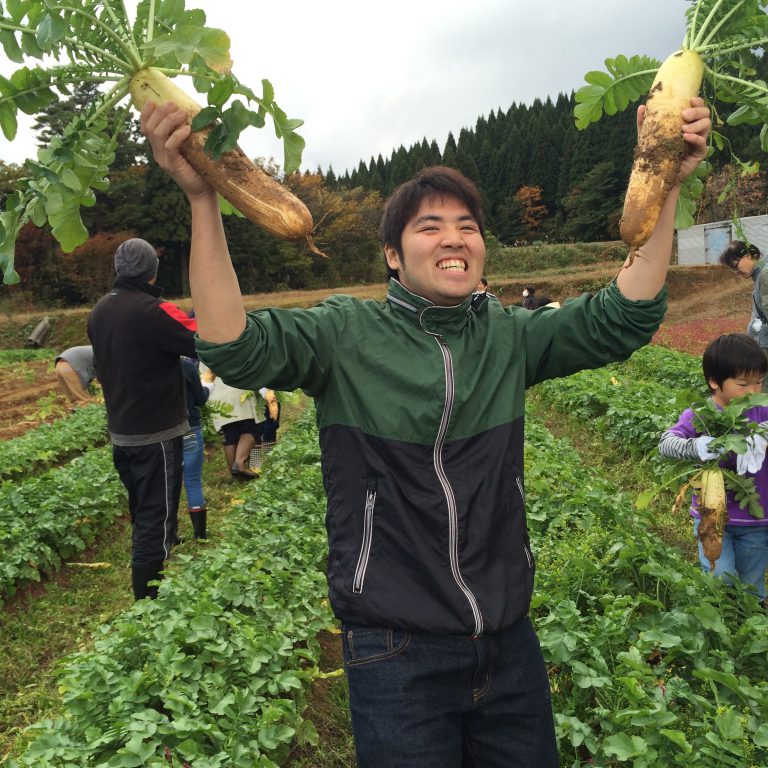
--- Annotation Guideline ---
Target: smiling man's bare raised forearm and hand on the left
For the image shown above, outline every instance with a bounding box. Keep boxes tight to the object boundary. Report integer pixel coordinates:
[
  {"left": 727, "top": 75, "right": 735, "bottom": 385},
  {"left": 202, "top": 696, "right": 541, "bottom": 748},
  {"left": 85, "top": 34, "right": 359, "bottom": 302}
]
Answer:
[{"left": 141, "top": 102, "right": 245, "bottom": 342}]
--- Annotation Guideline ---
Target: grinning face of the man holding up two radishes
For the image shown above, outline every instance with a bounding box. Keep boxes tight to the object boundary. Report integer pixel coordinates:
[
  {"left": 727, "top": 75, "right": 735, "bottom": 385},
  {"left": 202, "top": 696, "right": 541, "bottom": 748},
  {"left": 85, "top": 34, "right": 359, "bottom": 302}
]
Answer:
[{"left": 384, "top": 197, "right": 485, "bottom": 307}]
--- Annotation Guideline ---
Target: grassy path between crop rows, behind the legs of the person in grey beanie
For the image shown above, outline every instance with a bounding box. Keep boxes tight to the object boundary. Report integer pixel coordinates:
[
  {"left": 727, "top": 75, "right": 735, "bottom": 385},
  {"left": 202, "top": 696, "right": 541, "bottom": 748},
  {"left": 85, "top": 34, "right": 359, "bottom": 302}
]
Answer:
[{"left": 0, "top": 395, "right": 312, "bottom": 766}]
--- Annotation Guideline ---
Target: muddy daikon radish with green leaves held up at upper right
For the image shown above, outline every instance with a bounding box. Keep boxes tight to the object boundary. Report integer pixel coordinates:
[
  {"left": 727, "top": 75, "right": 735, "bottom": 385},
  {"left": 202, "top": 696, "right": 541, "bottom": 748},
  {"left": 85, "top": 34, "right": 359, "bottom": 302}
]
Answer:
[{"left": 574, "top": 0, "right": 768, "bottom": 263}]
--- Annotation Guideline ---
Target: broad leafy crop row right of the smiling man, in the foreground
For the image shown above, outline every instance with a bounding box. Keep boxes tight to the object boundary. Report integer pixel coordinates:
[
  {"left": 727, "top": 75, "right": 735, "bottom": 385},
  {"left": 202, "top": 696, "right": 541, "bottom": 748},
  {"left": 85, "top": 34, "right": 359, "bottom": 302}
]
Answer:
[{"left": 526, "top": 418, "right": 768, "bottom": 768}]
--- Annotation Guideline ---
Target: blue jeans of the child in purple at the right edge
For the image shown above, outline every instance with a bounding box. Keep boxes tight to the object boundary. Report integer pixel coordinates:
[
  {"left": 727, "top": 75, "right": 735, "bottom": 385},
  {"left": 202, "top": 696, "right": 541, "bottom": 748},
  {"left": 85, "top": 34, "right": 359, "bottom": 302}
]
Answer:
[{"left": 693, "top": 520, "right": 768, "bottom": 600}]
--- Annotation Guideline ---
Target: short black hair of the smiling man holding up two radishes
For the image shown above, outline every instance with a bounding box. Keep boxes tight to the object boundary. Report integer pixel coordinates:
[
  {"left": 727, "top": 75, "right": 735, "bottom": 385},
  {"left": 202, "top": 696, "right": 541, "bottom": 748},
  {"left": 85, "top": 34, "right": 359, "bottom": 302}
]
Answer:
[{"left": 379, "top": 165, "right": 485, "bottom": 278}]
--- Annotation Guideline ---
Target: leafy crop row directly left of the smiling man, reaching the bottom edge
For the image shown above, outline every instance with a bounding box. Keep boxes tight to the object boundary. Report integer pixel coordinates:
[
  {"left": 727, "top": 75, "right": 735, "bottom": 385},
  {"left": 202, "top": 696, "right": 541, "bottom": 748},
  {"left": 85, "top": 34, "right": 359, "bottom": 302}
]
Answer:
[{"left": 8, "top": 404, "right": 332, "bottom": 768}]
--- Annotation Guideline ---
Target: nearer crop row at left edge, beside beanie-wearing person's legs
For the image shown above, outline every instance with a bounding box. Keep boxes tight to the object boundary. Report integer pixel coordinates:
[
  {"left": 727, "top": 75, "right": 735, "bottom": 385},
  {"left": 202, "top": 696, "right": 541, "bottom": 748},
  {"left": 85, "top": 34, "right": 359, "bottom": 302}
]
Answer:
[{"left": 0, "top": 448, "right": 125, "bottom": 595}]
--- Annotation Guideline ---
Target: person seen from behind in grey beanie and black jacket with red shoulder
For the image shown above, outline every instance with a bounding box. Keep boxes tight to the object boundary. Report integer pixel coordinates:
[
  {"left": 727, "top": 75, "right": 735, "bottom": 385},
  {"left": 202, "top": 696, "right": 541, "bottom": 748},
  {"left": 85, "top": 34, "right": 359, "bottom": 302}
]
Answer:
[{"left": 88, "top": 238, "right": 197, "bottom": 600}]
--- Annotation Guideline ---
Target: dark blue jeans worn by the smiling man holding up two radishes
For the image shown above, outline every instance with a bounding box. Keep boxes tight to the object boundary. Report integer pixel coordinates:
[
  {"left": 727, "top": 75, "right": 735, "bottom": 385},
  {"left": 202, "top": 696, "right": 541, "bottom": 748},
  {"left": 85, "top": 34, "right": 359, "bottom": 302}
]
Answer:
[{"left": 342, "top": 617, "right": 559, "bottom": 768}]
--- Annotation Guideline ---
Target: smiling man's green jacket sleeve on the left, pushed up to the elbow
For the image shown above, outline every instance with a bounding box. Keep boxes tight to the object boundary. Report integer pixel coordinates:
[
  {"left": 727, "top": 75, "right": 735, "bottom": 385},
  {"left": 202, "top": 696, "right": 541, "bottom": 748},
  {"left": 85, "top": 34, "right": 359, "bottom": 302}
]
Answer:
[{"left": 197, "top": 296, "right": 354, "bottom": 397}]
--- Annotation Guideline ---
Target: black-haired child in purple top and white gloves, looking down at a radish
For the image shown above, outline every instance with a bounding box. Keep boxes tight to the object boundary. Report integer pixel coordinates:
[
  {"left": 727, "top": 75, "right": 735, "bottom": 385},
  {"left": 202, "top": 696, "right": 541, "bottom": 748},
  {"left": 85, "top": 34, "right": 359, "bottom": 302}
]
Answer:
[{"left": 659, "top": 333, "right": 768, "bottom": 604}]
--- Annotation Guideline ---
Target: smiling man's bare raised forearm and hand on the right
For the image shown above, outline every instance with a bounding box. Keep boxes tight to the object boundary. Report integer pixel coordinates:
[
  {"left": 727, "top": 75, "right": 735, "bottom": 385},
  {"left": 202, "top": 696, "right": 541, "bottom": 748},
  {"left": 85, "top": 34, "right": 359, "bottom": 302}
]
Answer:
[{"left": 616, "top": 96, "right": 711, "bottom": 300}]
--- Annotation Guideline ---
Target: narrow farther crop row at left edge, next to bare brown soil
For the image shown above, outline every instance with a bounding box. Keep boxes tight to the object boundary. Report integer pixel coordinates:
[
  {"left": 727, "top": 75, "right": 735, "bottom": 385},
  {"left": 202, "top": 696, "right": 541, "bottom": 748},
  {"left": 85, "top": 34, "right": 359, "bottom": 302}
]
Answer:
[{"left": 0, "top": 403, "right": 107, "bottom": 480}]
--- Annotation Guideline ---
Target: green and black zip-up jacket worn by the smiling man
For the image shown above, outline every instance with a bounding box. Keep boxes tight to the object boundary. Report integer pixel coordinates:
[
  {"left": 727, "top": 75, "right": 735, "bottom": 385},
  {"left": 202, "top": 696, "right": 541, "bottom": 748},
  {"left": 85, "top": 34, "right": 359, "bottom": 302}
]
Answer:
[{"left": 197, "top": 280, "right": 666, "bottom": 636}]
